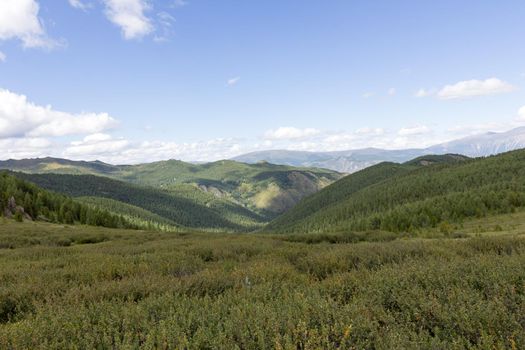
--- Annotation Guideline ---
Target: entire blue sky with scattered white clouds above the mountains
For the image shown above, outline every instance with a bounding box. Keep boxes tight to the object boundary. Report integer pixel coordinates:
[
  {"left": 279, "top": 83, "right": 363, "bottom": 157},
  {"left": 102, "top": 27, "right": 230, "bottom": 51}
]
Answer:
[{"left": 0, "top": 0, "right": 525, "bottom": 164}]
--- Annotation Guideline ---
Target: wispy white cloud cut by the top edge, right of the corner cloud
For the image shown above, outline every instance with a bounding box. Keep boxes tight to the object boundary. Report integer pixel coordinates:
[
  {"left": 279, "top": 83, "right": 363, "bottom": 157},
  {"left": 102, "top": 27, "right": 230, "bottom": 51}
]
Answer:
[{"left": 103, "top": 0, "right": 155, "bottom": 40}]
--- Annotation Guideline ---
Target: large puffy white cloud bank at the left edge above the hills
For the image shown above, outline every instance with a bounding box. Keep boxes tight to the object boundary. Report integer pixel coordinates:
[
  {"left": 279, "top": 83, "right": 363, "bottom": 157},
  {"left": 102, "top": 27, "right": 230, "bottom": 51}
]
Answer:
[{"left": 0, "top": 89, "right": 116, "bottom": 138}]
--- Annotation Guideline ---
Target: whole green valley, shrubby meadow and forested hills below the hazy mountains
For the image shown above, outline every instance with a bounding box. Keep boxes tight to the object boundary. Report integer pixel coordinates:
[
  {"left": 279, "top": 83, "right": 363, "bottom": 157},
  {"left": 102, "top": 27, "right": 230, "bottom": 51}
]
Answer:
[{"left": 0, "top": 150, "right": 525, "bottom": 349}]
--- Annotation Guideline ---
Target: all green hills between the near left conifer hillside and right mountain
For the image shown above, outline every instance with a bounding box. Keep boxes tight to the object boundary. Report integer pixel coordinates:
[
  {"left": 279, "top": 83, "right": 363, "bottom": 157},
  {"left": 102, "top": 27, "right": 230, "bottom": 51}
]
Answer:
[{"left": 0, "top": 157, "right": 343, "bottom": 231}]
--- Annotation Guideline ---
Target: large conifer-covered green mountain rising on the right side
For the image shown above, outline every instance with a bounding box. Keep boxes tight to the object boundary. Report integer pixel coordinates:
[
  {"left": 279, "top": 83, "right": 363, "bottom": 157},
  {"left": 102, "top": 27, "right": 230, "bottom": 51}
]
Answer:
[{"left": 266, "top": 150, "right": 525, "bottom": 233}]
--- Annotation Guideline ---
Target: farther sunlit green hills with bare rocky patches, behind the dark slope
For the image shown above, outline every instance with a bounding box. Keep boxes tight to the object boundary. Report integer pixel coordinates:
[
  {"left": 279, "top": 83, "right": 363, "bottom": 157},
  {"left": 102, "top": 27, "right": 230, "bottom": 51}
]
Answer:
[{"left": 0, "top": 158, "right": 342, "bottom": 218}]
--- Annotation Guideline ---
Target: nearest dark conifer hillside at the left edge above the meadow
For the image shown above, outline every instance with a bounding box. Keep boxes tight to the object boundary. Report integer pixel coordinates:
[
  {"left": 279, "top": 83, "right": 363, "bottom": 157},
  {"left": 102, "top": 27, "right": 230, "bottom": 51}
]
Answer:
[{"left": 0, "top": 172, "right": 140, "bottom": 228}]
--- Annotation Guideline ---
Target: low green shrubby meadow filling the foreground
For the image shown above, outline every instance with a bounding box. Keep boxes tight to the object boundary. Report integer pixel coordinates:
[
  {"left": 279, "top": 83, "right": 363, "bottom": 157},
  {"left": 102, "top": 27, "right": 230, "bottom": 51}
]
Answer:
[{"left": 0, "top": 216, "right": 525, "bottom": 349}]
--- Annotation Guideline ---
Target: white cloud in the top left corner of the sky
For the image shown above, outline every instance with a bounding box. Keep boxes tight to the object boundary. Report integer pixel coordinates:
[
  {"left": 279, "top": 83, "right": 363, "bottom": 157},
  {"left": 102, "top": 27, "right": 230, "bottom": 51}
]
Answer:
[{"left": 0, "top": 0, "right": 58, "bottom": 49}]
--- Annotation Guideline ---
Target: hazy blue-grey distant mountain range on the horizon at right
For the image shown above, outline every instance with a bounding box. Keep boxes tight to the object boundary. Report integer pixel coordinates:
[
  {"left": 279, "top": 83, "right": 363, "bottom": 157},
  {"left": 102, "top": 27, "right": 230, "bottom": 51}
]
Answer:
[{"left": 233, "top": 127, "right": 525, "bottom": 173}]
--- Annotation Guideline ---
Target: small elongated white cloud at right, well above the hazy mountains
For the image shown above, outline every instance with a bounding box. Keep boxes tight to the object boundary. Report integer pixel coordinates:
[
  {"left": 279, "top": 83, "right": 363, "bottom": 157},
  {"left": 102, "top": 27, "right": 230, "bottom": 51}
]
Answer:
[{"left": 437, "top": 78, "right": 515, "bottom": 100}]
